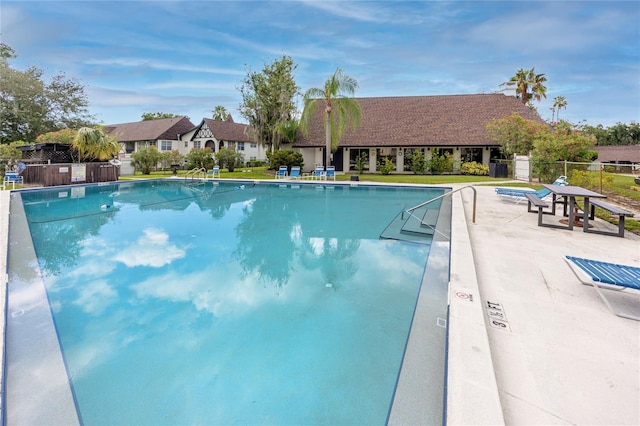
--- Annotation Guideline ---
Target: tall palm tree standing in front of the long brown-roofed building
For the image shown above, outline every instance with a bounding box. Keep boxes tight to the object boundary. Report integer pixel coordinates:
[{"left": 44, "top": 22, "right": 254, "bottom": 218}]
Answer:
[{"left": 300, "top": 68, "right": 362, "bottom": 166}]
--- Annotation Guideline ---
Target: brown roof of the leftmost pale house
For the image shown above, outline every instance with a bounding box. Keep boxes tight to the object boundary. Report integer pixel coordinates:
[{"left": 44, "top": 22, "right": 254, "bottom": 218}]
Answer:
[{"left": 103, "top": 117, "right": 194, "bottom": 142}]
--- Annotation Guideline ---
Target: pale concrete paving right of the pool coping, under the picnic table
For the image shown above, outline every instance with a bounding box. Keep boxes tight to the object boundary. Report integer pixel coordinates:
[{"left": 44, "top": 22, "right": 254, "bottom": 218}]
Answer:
[{"left": 449, "top": 186, "right": 640, "bottom": 425}]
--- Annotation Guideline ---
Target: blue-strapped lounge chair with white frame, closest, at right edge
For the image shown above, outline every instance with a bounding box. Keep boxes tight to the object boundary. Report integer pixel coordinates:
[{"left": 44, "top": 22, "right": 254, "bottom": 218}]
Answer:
[{"left": 565, "top": 256, "right": 640, "bottom": 321}]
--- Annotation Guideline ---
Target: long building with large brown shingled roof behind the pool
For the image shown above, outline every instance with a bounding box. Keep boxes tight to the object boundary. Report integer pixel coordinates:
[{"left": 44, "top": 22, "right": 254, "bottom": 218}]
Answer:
[{"left": 293, "top": 94, "right": 544, "bottom": 172}]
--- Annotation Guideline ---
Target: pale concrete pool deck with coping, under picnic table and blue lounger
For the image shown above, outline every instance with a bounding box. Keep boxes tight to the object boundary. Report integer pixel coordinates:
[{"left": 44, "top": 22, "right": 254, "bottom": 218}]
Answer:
[{"left": 0, "top": 185, "right": 640, "bottom": 425}]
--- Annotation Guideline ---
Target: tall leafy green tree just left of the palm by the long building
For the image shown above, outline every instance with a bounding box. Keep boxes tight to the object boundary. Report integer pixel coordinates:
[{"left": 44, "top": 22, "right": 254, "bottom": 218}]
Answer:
[{"left": 239, "top": 56, "right": 299, "bottom": 150}]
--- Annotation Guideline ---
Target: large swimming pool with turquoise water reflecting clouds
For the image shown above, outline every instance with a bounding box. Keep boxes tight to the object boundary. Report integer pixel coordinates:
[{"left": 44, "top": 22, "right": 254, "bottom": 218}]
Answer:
[{"left": 7, "top": 179, "right": 448, "bottom": 424}]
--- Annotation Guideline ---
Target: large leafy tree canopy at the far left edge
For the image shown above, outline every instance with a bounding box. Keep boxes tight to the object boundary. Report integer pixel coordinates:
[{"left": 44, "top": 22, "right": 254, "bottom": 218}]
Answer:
[{"left": 0, "top": 43, "right": 95, "bottom": 143}]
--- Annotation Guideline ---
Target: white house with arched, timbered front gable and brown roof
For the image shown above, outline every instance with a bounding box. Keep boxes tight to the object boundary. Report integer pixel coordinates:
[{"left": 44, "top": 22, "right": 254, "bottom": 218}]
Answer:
[{"left": 180, "top": 115, "right": 267, "bottom": 162}]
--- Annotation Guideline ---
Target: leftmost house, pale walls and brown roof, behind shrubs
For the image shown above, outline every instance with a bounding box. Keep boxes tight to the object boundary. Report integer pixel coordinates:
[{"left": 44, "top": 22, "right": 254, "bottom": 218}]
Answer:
[{"left": 103, "top": 117, "right": 194, "bottom": 175}]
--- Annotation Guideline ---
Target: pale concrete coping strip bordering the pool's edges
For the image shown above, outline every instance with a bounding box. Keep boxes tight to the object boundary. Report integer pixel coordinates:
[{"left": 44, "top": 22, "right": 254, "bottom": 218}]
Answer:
[{"left": 0, "top": 179, "right": 504, "bottom": 424}]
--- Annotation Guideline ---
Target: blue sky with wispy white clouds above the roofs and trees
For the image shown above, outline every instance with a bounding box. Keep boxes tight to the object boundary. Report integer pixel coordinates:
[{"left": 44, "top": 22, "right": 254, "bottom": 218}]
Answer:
[{"left": 0, "top": 0, "right": 640, "bottom": 127}]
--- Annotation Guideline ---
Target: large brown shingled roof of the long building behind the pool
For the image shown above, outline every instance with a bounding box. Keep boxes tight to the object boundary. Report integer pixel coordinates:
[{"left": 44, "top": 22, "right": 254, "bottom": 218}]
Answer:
[{"left": 294, "top": 94, "right": 543, "bottom": 148}]
